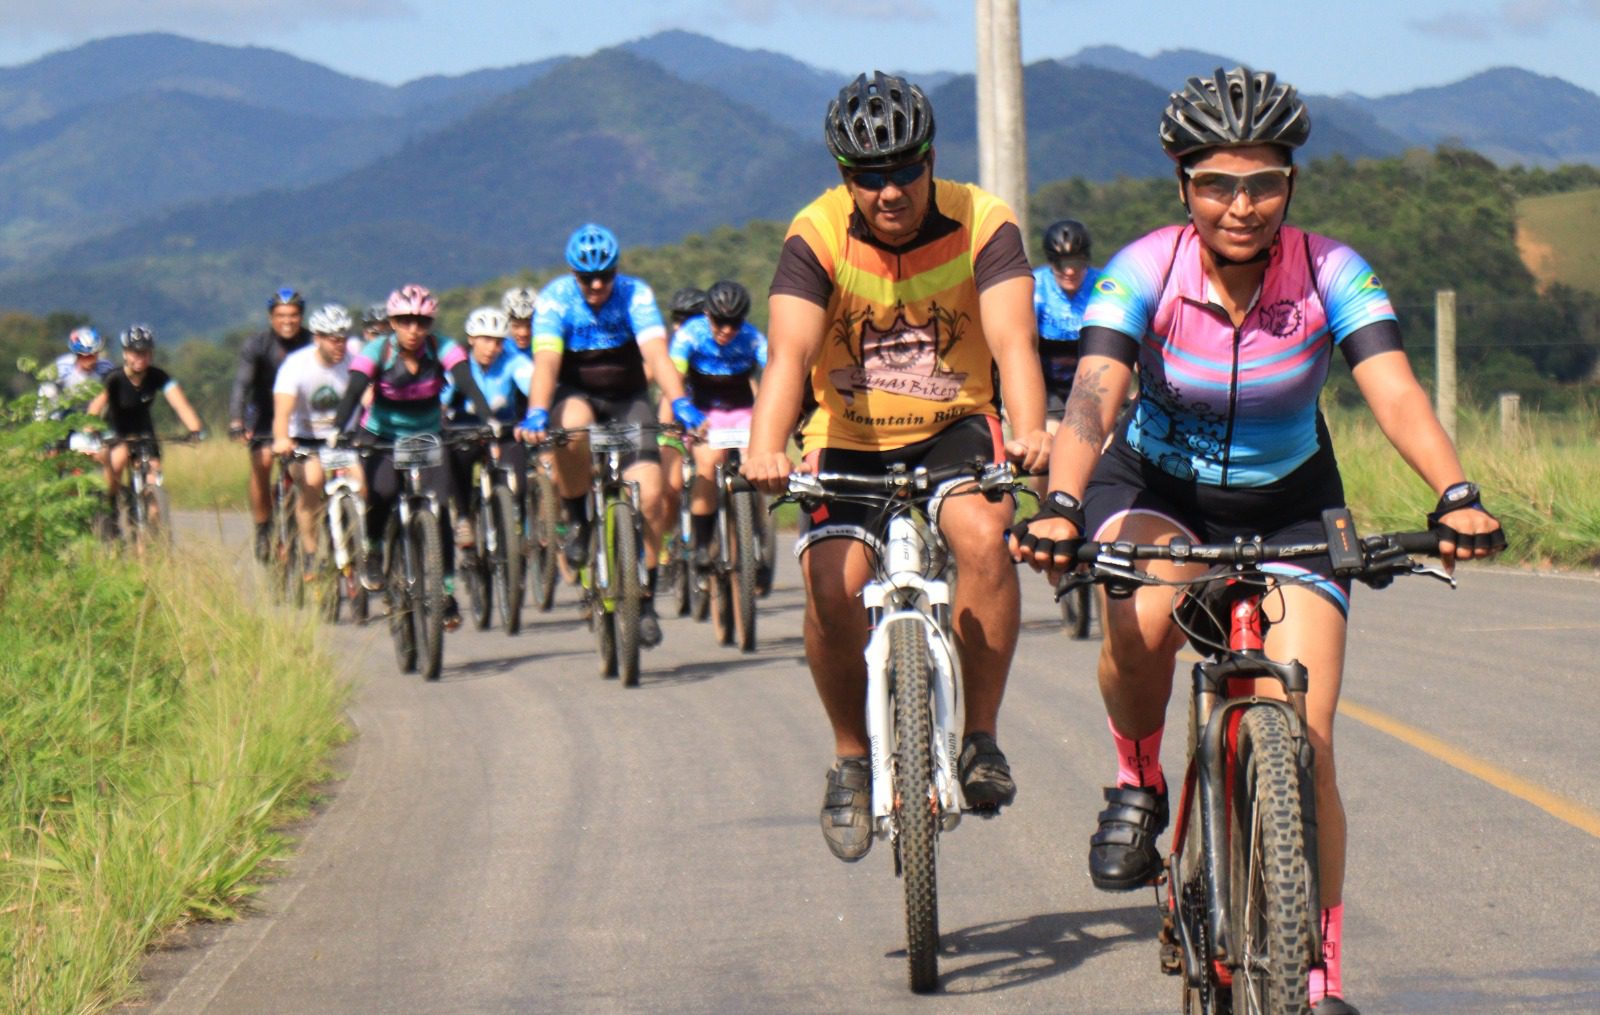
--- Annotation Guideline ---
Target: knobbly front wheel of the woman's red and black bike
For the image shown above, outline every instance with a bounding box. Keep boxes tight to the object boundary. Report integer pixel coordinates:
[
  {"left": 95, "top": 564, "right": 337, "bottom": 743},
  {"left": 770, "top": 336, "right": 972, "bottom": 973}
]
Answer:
[{"left": 1227, "top": 704, "right": 1317, "bottom": 1012}]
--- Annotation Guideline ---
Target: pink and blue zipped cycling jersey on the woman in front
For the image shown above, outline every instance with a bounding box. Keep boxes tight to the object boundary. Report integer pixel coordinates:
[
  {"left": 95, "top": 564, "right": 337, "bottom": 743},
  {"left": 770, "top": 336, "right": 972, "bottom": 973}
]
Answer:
[{"left": 1083, "top": 226, "right": 1400, "bottom": 487}]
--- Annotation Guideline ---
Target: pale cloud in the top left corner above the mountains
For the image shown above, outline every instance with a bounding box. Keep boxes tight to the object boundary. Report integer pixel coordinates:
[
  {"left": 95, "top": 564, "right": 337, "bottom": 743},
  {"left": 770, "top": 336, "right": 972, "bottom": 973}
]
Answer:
[{"left": 5, "top": 0, "right": 416, "bottom": 42}]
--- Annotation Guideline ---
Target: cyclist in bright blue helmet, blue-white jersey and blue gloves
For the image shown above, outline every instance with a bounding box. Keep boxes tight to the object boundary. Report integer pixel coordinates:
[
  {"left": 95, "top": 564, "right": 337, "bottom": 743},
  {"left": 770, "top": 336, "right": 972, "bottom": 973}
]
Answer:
[{"left": 522, "top": 223, "right": 704, "bottom": 647}]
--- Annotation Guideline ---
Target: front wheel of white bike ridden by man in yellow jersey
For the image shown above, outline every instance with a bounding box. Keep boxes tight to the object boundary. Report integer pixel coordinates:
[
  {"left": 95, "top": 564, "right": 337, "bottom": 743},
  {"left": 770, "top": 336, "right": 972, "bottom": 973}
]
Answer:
[{"left": 890, "top": 621, "right": 939, "bottom": 994}]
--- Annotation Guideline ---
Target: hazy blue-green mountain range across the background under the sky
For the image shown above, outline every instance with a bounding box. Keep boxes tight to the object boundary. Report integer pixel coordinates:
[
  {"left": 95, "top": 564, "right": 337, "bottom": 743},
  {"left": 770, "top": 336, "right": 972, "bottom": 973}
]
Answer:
[{"left": 0, "top": 32, "right": 1600, "bottom": 335}]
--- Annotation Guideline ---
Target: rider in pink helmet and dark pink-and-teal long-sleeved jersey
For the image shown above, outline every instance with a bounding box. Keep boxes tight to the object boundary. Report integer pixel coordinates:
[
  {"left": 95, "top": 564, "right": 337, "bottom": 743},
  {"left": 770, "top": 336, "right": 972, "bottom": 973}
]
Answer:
[{"left": 333, "top": 285, "right": 493, "bottom": 631}]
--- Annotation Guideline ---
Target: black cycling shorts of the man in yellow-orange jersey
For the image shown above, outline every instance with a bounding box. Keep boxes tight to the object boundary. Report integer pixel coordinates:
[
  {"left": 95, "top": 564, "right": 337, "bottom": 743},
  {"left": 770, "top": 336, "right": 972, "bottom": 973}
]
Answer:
[{"left": 795, "top": 416, "right": 1005, "bottom": 557}]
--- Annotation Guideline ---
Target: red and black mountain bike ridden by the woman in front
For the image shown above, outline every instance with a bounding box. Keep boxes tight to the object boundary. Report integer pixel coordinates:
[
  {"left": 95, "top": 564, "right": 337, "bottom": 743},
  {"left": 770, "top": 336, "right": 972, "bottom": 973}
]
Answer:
[{"left": 1058, "top": 509, "right": 1456, "bottom": 1015}]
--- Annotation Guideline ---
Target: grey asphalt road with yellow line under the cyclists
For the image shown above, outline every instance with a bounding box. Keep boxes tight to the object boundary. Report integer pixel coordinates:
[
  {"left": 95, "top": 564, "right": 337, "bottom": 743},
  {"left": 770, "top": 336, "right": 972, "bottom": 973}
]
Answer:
[{"left": 137, "top": 525, "right": 1600, "bottom": 1015}]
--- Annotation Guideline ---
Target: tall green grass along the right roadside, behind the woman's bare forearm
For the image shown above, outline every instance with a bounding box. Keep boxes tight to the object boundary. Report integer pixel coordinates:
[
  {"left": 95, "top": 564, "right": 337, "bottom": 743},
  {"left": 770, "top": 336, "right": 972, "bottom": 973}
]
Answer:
[{"left": 1328, "top": 400, "right": 1600, "bottom": 567}]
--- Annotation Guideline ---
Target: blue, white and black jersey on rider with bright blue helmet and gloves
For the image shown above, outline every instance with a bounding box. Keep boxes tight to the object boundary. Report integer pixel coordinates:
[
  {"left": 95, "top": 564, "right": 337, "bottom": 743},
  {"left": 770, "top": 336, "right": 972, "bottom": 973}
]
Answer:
[{"left": 533, "top": 275, "right": 667, "bottom": 399}]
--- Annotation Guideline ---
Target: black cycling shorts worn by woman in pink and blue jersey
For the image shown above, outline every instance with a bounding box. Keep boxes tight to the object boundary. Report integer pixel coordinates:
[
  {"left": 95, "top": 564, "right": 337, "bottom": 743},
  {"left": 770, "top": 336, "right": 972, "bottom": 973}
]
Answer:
[{"left": 1083, "top": 432, "right": 1350, "bottom": 616}]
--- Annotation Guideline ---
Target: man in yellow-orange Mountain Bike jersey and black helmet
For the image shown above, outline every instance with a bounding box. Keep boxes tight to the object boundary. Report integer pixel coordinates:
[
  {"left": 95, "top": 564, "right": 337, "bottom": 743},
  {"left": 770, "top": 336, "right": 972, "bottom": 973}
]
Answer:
[{"left": 744, "top": 74, "right": 1050, "bottom": 860}]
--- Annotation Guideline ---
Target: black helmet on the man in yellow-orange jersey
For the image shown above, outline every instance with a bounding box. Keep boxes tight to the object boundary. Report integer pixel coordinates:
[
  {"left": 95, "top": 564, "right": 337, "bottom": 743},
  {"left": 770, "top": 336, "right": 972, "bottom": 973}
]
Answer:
[{"left": 822, "top": 70, "right": 933, "bottom": 168}]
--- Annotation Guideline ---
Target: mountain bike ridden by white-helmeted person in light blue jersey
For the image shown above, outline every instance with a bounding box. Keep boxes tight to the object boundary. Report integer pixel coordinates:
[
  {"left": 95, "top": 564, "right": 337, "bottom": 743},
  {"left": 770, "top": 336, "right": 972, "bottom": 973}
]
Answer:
[{"left": 448, "top": 427, "right": 523, "bottom": 634}]
